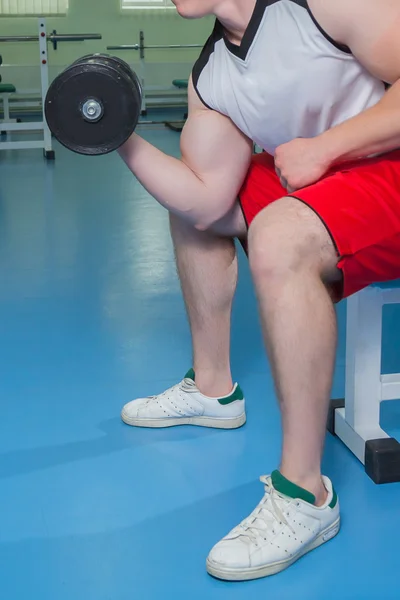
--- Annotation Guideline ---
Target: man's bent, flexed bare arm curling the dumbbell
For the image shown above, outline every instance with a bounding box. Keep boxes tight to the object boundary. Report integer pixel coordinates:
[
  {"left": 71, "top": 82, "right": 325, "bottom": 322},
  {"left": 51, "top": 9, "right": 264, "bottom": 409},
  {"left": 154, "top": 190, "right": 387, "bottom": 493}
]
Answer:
[{"left": 119, "top": 81, "right": 252, "bottom": 229}]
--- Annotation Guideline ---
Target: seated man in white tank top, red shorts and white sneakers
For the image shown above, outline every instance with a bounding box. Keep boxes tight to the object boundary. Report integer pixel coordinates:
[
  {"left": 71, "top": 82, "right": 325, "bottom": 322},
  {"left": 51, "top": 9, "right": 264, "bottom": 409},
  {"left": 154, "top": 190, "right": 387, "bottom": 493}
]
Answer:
[{"left": 115, "top": 0, "right": 400, "bottom": 580}]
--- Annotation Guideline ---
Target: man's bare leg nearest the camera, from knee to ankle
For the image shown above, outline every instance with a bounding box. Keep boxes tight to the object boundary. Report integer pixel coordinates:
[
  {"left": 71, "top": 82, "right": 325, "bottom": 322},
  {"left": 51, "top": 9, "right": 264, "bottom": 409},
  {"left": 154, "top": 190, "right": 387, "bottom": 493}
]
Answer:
[{"left": 249, "top": 198, "right": 340, "bottom": 504}]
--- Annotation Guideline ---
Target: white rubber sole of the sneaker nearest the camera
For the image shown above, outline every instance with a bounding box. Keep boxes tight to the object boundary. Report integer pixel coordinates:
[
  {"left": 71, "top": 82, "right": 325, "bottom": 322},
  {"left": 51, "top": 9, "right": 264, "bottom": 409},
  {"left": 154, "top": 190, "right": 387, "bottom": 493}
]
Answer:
[{"left": 207, "top": 517, "right": 340, "bottom": 581}]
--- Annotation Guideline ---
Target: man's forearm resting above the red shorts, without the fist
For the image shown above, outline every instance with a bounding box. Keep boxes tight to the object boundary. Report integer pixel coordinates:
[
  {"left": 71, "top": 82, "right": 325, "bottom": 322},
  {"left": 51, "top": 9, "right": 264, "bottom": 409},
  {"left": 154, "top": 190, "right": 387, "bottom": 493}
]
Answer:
[{"left": 316, "top": 81, "right": 400, "bottom": 165}]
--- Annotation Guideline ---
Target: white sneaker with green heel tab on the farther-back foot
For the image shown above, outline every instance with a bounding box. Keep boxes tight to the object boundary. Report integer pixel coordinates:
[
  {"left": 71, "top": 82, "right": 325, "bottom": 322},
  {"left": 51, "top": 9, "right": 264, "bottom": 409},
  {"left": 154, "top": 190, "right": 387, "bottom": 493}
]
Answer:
[{"left": 121, "top": 369, "right": 246, "bottom": 429}]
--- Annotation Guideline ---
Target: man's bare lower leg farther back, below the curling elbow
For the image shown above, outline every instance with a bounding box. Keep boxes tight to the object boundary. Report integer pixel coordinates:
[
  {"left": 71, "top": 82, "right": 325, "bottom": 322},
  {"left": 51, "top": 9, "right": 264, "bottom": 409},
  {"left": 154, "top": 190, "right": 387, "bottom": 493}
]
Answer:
[{"left": 170, "top": 207, "right": 245, "bottom": 397}]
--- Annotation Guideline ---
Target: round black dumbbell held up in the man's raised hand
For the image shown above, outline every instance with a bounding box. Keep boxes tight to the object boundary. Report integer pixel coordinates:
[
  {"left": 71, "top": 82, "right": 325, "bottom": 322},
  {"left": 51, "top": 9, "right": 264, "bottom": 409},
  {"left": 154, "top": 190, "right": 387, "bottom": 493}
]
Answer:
[{"left": 45, "top": 54, "right": 142, "bottom": 155}]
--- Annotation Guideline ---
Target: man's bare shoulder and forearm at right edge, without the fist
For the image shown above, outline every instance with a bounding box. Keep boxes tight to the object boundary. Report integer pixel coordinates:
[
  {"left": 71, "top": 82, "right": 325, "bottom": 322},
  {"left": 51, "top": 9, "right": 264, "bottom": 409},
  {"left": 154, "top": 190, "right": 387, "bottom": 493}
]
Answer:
[{"left": 309, "top": 0, "right": 400, "bottom": 164}]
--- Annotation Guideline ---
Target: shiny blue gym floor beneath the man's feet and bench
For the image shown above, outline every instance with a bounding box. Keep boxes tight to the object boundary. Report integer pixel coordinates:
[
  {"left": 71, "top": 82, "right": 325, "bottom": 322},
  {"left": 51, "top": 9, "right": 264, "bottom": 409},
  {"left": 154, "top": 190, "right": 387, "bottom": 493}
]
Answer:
[{"left": 0, "top": 118, "right": 400, "bottom": 600}]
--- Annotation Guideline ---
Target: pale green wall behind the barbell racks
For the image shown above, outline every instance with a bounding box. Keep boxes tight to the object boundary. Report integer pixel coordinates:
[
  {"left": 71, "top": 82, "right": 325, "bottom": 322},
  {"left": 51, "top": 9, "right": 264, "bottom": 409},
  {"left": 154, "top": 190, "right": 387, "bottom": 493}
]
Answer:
[{"left": 0, "top": 0, "right": 213, "bottom": 83}]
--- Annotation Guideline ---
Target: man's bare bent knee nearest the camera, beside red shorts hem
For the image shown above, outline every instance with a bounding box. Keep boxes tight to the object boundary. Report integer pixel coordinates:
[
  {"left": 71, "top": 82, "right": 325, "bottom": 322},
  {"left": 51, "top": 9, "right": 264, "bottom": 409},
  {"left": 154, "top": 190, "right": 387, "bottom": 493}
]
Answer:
[{"left": 248, "top": 198, "right": 332, "bottom": 280}]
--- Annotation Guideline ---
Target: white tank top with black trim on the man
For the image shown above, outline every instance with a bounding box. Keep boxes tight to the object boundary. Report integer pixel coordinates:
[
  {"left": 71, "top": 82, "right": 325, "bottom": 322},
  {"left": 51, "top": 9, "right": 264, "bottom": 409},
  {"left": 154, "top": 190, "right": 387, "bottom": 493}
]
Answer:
[{"left": 192, "top": 0, "right": 385, "bottom": 154}]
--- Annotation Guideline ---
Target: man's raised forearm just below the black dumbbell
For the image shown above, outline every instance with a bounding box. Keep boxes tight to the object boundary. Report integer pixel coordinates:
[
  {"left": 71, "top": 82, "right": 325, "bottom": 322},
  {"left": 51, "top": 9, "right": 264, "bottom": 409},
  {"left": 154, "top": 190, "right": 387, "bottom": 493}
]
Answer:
[{"left": 119, "top": 134, "right": 220, "bottom": 227}]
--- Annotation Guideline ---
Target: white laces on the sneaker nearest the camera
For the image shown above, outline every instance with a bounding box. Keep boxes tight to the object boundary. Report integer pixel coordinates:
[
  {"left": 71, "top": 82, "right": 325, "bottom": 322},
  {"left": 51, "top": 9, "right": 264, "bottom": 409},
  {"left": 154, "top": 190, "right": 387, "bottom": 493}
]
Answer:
[{"left": 239, "top": 476, "right": 295, "bottom": 542}]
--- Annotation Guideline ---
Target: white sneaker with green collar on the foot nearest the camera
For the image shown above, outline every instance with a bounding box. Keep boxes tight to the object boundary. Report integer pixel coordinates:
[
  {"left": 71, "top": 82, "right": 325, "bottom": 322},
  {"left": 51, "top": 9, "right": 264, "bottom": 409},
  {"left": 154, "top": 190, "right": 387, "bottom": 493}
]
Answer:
[{"left": 207, "top": 471, "right": 340, "bottom": 581}]
